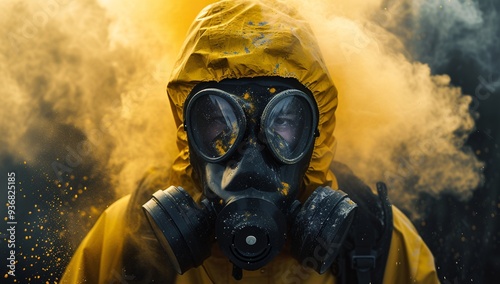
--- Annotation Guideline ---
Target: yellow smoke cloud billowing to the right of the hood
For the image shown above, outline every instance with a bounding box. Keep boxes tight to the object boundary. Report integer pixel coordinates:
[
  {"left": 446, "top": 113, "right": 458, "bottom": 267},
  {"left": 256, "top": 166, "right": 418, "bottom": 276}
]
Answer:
[{"left": 286, "top": 1, "right": 482, "bottom": 209}]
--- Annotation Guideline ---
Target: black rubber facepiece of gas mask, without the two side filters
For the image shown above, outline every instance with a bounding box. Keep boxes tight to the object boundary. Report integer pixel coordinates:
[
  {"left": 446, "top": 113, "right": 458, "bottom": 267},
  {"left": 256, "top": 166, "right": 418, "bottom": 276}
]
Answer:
[{"left": 186, "top": 79, "right": 317, "bottom": 270}]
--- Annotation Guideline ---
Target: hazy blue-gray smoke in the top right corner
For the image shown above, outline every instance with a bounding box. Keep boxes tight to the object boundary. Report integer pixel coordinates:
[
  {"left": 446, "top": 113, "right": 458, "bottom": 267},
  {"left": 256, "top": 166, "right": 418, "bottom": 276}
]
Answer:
[{"left": 374, "top": 0, "right": 500, "bottom": 85}]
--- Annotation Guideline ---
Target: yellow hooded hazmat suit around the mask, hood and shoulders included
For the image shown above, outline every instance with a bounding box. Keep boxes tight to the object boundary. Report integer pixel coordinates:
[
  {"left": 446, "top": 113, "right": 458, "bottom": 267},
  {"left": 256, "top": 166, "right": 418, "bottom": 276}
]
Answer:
[{"left": 61, "top": 1, "right": 438, "bottom": 284}]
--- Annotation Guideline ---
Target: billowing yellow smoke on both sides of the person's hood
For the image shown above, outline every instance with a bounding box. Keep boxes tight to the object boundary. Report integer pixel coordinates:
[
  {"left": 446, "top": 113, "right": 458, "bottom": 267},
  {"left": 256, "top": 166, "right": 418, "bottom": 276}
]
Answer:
[{"left": 0, "top": 0, "right": 481, "bottom": 212}]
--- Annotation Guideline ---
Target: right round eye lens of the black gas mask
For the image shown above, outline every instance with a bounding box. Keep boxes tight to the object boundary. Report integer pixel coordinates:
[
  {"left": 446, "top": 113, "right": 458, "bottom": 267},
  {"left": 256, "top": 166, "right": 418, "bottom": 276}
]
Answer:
[{"left": 261, "top": 90, "right": 316, "bottom": 163}]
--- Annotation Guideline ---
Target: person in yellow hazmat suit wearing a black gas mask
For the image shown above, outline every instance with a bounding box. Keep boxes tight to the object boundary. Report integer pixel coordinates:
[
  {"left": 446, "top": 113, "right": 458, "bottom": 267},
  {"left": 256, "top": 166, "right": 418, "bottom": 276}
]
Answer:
[{"left": 61, "top": 0, "right": 438, "bottom": 283}]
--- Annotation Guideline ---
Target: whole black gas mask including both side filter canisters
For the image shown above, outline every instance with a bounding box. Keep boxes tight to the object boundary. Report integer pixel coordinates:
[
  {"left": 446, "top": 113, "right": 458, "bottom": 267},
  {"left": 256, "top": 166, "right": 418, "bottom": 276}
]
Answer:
[{"left": 143, "top": 77, "right": 356, "bottom": 279}]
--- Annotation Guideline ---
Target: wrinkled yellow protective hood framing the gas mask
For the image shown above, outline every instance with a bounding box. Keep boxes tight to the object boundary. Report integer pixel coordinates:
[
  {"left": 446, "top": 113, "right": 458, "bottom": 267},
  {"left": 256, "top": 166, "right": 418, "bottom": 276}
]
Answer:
[{"left": 167, "top": 0, "right": 337, "bottom": 200}]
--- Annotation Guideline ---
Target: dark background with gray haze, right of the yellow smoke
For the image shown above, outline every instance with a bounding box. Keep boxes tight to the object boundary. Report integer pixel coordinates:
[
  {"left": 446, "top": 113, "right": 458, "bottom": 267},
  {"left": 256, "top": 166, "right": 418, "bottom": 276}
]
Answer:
[{"left": 386, "top": 0, "right": 500, "bottom": 283}]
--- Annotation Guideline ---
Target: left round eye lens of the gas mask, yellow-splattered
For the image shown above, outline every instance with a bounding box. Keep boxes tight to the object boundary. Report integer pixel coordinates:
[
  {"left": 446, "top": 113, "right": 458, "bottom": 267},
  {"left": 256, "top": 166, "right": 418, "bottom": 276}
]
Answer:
[{"left": 186, "top": 89, "right": 245, "bottom": 161}]
